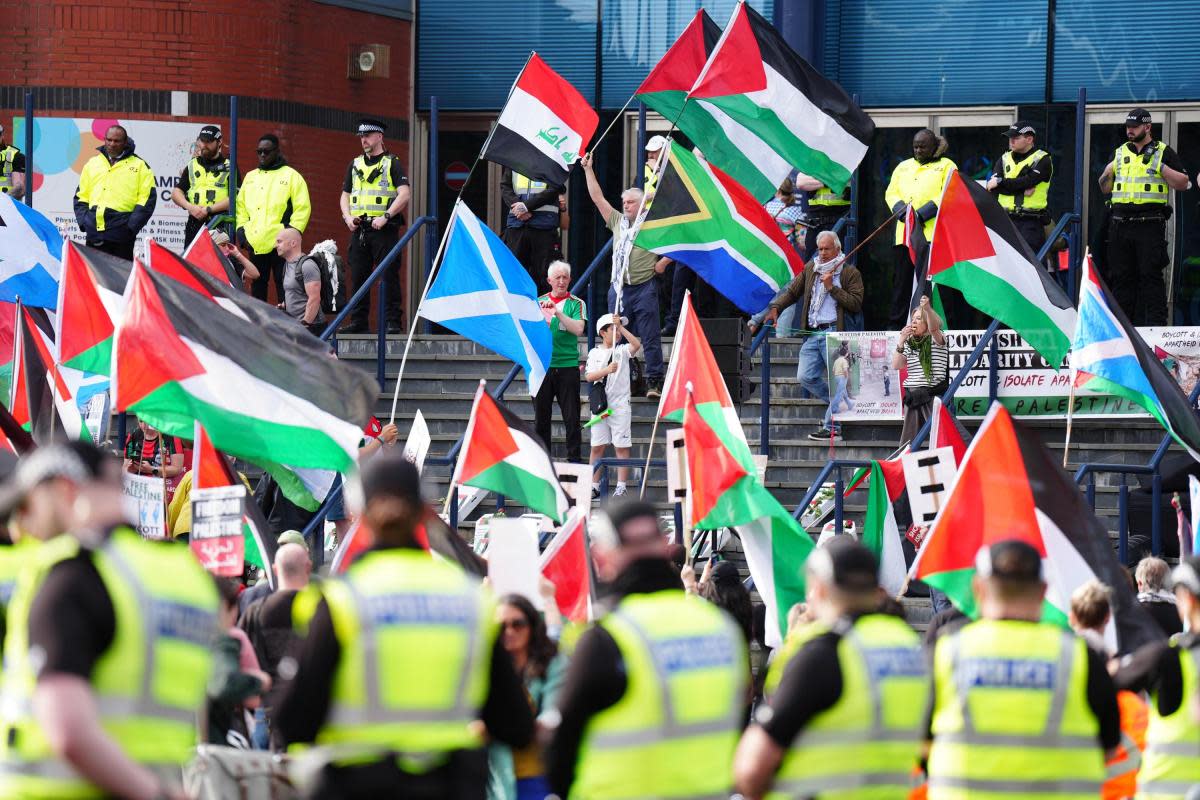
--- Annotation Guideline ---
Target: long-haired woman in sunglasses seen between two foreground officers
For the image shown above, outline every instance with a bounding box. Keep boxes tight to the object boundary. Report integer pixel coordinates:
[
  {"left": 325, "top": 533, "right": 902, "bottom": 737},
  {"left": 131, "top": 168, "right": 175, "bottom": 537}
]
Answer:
[{"left": 487, "top": 581, "right": 566, "bottom": 800}]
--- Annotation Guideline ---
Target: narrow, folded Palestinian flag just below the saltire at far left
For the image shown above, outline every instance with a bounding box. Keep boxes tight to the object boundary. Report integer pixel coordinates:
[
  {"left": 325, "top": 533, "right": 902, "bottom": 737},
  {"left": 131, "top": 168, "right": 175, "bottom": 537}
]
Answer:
[{"left": 8, "top": 302, "right": 91, "bottom": 445}]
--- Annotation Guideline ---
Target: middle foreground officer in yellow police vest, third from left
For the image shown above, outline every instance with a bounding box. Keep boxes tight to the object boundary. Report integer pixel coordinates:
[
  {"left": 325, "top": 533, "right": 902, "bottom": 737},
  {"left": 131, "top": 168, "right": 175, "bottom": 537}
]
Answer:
[{"left": 546, "top": 500, "right": 749, "bottom": 800}]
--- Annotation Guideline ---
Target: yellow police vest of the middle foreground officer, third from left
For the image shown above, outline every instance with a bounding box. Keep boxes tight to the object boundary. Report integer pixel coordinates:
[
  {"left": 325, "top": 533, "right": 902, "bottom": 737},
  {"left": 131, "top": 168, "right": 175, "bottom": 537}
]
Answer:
[{"left": 571, "top": 590, "right": 749, "bottom": 800}]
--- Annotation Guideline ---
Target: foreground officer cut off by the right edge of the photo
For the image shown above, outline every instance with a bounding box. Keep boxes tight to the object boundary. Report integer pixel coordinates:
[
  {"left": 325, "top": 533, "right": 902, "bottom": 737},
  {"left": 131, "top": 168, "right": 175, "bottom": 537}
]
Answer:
[{"left": 1116, "top": 555, "right": 1200, "bottom": 800}]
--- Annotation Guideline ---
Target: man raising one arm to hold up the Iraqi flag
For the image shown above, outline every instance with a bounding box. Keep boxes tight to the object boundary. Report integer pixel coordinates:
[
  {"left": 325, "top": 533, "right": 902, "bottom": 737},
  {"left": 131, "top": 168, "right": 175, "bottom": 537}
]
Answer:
[{"left": 580, "top": 154, "right": 671, "bottom": 397}]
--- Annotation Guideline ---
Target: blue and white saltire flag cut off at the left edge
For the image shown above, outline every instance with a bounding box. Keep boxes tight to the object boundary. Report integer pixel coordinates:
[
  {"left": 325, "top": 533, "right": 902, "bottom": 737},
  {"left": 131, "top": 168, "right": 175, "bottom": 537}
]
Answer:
[{"left": 0, "top": 193, "right": 62, "bottom": 308}]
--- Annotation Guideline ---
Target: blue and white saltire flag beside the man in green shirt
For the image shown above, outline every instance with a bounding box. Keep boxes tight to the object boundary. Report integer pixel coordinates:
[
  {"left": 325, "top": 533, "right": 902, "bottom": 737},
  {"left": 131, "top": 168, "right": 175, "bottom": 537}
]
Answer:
[{"left": 418, "top": 200, "right": 551, "bottom": 395}]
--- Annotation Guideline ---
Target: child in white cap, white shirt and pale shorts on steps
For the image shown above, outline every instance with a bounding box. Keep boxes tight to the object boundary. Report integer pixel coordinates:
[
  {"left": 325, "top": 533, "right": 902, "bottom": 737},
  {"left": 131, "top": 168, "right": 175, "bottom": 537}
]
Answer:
[{"left": 583, "top": 314, "right": 642, "bottom": 497}]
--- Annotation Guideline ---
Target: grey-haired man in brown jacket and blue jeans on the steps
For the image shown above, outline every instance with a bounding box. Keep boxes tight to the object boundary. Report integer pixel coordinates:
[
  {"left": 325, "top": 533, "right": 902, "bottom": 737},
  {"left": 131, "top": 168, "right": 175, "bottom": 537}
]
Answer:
[{"left": 750, "top": 230, "right": 863, "bottom": 440}]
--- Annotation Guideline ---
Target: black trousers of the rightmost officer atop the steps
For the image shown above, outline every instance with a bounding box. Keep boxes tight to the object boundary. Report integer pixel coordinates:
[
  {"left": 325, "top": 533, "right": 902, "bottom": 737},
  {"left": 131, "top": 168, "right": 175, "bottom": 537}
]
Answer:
[{"left": 1106, "top": 217, "right": 1170, "bottom": 325}]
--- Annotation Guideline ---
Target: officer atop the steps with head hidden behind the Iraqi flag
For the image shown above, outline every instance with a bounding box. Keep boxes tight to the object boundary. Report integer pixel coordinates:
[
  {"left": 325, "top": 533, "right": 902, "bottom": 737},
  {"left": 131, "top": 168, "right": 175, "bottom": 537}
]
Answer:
[{"left": 500, "top": 167, "right": 566, "bottom": 295}]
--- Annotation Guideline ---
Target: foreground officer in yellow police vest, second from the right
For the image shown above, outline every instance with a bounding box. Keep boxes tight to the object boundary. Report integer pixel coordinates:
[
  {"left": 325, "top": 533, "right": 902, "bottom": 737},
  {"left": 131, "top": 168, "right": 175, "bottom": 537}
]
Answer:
[{"left": 928, "top": 541, "right": 1121, "bottom": 800}]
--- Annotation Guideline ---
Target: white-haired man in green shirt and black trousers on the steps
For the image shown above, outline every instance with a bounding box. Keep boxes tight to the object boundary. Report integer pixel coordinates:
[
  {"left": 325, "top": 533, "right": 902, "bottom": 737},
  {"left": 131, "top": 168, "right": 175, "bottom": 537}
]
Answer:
[{"left": 533, "top": 261, "right": 588, "bottom": 464}]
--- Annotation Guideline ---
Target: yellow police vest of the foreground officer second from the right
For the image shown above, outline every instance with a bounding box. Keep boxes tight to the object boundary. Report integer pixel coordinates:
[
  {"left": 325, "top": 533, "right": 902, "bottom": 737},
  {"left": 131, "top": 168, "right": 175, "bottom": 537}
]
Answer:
[{"left": 928, "top": 620, "right": 1105, "bottom": 800}]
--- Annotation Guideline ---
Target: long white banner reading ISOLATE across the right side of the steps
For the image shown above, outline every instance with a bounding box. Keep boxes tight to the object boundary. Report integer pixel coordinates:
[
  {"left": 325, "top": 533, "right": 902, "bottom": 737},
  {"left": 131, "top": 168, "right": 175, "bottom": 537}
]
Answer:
[{"left": 826, "top": 327, "right": 1200, "bottom": 422}]
